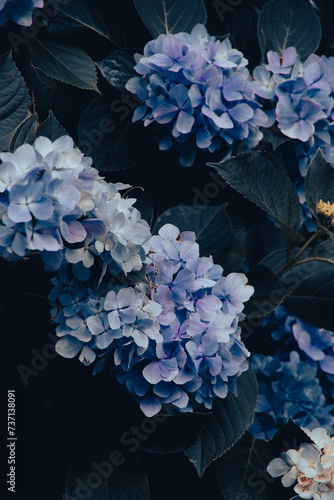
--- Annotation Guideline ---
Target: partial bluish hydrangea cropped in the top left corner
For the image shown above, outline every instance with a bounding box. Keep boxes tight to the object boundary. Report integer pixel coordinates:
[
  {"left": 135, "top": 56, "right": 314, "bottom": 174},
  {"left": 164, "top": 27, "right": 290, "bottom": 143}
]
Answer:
[{"left": 0, "top": 0, "right": 44, "bottom": 26}]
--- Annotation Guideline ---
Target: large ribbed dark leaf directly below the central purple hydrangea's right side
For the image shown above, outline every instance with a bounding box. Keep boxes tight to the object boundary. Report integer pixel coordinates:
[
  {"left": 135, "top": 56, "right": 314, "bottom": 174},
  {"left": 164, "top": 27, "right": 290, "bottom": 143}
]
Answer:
[{"left": 185, "top": 368, "right": 257, "bottom": 477}]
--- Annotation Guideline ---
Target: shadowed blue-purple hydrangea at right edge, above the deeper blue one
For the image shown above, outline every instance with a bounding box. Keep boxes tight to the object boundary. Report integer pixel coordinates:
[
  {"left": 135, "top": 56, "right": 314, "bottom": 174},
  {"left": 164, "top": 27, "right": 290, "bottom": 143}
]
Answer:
[{"left": 263, "top": 306, "right": 334, "bottom": 395}]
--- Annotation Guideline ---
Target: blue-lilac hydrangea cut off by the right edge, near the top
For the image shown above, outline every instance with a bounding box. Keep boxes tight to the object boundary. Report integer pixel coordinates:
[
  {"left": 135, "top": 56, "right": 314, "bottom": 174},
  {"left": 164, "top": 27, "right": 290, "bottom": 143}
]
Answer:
[{"left": 252, "top": 47, "right": 334, "bottom": 177}]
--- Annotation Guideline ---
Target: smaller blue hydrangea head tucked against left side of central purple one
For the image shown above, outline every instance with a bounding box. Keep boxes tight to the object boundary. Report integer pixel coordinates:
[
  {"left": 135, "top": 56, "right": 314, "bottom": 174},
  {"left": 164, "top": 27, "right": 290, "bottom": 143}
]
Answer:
[{"left": 49, "top": 270, "right": 161, "bottom": 366}]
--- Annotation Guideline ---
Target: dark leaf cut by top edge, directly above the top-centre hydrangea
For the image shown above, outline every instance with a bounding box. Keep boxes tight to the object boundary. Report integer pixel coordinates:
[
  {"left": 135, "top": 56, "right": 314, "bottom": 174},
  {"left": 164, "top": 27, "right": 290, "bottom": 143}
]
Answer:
[{"left": 134, "top": 0, "right": 206, "bottom": 38}]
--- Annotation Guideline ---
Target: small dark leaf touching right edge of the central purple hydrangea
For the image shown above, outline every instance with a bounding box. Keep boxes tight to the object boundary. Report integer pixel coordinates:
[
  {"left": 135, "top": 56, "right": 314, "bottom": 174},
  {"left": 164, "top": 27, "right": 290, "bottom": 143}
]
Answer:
[{"left": 243, "top": 265, "right": 290, "bottom": 318}]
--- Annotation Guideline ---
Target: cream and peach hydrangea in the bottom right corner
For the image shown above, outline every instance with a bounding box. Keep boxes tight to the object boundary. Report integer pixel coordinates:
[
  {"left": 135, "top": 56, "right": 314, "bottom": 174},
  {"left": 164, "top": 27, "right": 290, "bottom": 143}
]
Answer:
[{"left": 267, "top": 427, "right": 334, "bottom": 500}]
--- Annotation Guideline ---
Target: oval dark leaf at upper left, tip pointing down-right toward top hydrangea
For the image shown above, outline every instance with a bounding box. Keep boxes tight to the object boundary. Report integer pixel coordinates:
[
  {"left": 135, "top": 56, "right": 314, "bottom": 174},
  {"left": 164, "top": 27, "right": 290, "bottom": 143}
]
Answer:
[{"left": 30, "top": 38, "right": 99, "bottom": 92}]
